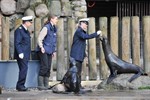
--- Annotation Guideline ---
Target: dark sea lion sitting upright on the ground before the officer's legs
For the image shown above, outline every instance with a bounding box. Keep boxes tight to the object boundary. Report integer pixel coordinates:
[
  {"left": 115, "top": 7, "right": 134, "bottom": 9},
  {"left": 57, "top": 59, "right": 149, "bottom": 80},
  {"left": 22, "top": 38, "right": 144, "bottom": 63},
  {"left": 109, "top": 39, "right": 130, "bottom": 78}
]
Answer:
[{"left": 51, "top": 57, "right": 92, "bottom": 94}]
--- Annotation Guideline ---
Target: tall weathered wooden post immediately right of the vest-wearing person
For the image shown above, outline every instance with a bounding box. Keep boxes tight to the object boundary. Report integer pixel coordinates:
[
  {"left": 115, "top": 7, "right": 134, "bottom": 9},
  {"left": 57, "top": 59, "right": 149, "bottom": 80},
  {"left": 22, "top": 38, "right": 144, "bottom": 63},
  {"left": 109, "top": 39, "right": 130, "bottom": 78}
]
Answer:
[{"left": 56, "top": 18, "right": 67, "bottom": 80}]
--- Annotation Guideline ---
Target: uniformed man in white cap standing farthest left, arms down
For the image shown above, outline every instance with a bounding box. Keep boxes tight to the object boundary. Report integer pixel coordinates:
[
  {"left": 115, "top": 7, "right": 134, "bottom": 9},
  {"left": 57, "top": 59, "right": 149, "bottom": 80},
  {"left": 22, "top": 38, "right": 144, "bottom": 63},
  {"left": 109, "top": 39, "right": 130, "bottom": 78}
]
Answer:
[{"left": 14, "top": 16, "right": 33, "bottom": 91}]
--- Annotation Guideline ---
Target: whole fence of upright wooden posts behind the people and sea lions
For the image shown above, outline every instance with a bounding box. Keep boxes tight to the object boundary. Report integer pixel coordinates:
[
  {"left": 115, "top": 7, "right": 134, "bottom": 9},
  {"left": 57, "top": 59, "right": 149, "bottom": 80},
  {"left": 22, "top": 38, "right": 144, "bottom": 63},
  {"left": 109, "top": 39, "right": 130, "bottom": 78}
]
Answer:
[{"left": 1, "top": 16, "right": 150, "bottom": 80}]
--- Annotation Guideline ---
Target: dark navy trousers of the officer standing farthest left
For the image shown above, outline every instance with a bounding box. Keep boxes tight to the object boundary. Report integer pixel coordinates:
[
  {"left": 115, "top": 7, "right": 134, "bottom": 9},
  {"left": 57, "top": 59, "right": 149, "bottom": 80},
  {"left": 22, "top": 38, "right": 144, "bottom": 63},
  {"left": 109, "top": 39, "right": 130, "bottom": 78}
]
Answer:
[{"left": 16, "top": 59, "right": 28, "bottom": 88}]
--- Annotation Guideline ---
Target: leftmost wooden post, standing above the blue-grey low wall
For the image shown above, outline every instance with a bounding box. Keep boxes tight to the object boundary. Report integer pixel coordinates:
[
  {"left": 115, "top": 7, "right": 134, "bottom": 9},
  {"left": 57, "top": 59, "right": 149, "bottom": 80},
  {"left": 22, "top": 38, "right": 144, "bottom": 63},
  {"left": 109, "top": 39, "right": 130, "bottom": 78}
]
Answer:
[{"left": 2, "top": 17, "right": 9, "bottom": 60}]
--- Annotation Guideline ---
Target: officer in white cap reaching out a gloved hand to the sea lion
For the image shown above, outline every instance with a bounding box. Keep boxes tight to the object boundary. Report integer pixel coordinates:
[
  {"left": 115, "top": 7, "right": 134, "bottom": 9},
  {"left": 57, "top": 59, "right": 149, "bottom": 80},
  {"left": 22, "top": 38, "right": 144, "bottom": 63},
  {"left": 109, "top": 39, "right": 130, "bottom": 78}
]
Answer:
[{"left": 70, "top": 18, "right": 102, "bottom": 92}]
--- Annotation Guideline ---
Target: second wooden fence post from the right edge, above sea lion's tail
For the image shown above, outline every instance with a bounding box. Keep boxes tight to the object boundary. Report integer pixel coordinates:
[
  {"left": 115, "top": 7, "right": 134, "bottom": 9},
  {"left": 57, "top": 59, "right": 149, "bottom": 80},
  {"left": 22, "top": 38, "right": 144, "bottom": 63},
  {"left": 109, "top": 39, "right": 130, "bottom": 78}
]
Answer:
[{"left": 131, "top": 16, "right": 140, "bottom": 66}]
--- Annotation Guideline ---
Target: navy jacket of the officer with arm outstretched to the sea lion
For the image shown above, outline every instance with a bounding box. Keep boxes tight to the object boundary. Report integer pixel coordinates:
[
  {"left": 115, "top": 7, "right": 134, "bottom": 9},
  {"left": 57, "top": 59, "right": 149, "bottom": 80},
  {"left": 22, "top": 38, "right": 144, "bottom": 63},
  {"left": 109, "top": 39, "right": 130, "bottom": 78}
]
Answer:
[{"left": 70, "top": 27, "right": 98, "bottom": 61}]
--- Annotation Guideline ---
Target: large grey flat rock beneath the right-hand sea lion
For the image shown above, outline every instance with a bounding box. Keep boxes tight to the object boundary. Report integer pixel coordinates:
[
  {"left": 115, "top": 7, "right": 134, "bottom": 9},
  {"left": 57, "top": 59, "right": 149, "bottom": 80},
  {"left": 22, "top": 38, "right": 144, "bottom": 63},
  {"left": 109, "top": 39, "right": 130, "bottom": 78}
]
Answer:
[{"left": 98, "top": 74, "right": 150, "bottom": 90}]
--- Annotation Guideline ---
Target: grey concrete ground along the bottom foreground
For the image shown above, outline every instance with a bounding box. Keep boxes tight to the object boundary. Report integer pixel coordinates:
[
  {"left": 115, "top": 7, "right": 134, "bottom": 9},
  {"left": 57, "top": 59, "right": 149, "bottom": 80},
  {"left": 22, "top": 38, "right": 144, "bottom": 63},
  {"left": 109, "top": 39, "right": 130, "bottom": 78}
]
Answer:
[{"left": 0, "top": 81, "right": 150, "bottom": 100}]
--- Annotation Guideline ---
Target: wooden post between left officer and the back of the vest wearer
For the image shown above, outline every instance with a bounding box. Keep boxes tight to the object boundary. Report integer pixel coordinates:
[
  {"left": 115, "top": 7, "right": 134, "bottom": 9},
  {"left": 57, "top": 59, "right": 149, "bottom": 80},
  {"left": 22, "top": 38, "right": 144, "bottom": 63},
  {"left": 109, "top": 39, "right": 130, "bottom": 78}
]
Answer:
[{"left": 33, "top": 18, "right": 42, "bottom": 49}]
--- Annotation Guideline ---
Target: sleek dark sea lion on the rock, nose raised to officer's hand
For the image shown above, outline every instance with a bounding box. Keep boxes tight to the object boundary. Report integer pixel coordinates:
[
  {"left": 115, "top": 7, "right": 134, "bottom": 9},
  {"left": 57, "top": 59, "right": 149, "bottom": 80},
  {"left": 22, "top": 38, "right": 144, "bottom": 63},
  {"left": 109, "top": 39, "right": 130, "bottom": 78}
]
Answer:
[{"left": 100, "top": 36, "right": 147, "bottom": 84}]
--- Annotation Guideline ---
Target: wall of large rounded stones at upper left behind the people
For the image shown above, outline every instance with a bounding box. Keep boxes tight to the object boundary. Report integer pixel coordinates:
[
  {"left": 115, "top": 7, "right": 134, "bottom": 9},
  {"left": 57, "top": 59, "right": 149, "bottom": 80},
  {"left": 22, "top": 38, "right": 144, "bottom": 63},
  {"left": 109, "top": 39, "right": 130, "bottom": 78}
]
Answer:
[{"left": 0, "top": 0, "right": 87, "bottom": 59}]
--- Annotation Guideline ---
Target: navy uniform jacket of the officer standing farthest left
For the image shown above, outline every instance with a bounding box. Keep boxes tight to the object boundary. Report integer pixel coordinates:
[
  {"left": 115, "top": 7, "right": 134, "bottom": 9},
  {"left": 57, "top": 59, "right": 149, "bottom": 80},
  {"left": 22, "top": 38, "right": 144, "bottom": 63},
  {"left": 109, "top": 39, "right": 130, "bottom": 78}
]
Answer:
[{"left": 14, "top": 25, "right": 31, "bottom": 60}]
